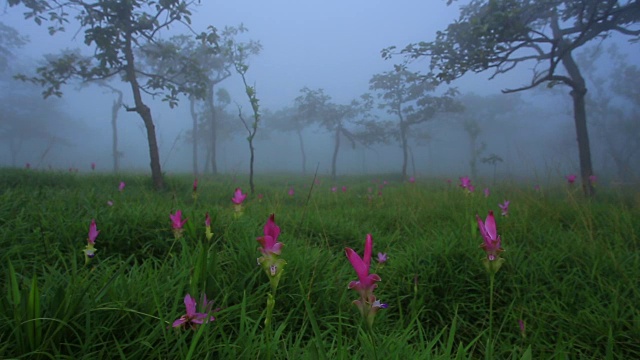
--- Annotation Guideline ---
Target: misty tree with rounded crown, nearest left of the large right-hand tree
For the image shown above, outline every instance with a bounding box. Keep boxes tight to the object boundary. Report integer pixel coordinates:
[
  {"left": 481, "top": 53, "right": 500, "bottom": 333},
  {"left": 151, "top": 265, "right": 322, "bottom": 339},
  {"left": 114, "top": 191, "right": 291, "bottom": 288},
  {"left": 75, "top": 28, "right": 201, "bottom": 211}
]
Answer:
[{"left": 369, "top": 65, "right": 462, "bottom": 180}]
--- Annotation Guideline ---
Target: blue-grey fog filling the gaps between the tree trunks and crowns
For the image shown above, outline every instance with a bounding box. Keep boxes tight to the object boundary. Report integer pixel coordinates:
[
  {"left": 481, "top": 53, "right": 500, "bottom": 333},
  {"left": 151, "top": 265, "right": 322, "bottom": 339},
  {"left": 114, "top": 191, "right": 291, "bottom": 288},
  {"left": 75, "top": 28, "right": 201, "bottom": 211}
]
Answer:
[{"left": 0, "top": 0, "right": 640, "bottom": 182}]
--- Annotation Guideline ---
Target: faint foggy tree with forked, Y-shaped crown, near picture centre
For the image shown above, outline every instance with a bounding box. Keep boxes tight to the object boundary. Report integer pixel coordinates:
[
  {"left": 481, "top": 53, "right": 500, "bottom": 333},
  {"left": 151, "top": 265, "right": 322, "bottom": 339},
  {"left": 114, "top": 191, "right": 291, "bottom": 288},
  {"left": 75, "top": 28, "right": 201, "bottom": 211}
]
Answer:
[{"left": 296, "top": 87, "right": 373, "bottom": 180}]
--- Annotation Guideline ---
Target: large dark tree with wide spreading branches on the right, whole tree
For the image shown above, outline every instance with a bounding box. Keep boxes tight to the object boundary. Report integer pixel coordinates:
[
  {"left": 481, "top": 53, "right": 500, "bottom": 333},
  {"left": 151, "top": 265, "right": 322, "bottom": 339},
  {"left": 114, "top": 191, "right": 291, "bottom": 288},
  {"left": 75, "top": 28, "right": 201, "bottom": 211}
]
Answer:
[{"left": 382, "top": 0, "right": 640, "bottom": 196}]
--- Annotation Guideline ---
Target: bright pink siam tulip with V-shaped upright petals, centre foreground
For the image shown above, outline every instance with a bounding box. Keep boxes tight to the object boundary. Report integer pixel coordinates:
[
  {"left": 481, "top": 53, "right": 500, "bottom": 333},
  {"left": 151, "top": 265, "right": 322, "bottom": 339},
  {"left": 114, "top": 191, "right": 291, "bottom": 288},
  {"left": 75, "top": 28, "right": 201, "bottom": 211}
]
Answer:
[{"left": 345, "top": 234, "right": 387, "bottom": 328}]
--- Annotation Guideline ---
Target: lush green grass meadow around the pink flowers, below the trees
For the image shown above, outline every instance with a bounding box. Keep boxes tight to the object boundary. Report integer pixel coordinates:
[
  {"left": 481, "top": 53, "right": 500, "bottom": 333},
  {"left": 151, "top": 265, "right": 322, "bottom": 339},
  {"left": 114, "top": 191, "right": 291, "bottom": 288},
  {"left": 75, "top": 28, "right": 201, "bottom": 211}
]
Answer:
[{"left": 0, "top": 169, "right": 640, "bottom": 359}]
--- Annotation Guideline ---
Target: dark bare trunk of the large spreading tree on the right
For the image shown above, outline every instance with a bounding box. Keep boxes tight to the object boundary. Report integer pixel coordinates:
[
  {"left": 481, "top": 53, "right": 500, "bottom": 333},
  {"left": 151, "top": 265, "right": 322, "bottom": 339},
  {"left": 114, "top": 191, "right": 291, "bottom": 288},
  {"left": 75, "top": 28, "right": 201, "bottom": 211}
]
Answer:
[{"left": 562, "top": 52, "right": 595, "bottom": 196}]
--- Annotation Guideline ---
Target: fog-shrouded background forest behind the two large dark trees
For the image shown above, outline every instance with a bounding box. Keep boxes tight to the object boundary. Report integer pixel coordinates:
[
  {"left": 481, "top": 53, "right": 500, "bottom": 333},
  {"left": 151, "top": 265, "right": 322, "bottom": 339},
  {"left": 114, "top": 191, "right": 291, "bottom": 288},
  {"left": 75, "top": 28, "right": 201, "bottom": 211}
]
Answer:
[{"left": 0, "top": 1, "right": 640, "bottom": 188}]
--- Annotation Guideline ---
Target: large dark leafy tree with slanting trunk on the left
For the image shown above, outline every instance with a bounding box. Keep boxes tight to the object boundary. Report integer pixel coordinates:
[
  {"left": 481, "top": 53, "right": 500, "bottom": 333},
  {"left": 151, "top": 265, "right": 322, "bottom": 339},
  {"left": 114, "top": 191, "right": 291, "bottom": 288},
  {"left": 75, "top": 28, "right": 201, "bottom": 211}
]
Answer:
[{"left": 8, "top": 0, "right": 205, "bottom": 189}]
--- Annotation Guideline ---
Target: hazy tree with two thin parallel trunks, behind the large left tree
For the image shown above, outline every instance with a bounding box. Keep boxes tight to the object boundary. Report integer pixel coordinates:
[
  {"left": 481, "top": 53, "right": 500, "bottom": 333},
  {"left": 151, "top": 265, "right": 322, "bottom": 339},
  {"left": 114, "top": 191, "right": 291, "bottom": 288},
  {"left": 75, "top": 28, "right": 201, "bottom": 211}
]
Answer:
[{"left": 141, "top": 25, "right": 262, "bottom": 175}]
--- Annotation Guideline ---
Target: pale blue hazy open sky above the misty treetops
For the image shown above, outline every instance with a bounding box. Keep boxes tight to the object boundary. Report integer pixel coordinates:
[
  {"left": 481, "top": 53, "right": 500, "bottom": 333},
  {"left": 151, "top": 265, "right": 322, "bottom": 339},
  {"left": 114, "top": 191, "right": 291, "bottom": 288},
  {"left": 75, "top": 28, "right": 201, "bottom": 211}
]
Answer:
[{"left": 0, "top": 0, "right": 501, "bottom": 109}]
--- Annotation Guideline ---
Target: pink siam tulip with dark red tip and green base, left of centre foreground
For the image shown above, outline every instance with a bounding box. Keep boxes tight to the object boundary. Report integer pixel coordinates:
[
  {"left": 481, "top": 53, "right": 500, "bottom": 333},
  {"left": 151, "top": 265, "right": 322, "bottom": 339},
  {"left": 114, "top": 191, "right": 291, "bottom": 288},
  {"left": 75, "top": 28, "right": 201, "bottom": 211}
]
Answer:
[{"left": 256, "top": 214, "right": 287, "bottom": 293}]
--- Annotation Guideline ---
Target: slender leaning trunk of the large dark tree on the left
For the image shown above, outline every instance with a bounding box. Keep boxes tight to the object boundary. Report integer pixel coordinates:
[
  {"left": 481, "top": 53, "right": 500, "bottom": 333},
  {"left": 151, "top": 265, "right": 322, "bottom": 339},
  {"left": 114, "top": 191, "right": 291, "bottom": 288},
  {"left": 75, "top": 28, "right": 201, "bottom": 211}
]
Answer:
[{"left": 124, "top": 34, "right": 164, "bottom": 190}]
